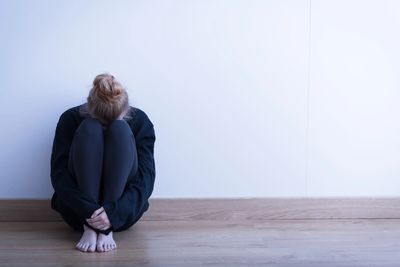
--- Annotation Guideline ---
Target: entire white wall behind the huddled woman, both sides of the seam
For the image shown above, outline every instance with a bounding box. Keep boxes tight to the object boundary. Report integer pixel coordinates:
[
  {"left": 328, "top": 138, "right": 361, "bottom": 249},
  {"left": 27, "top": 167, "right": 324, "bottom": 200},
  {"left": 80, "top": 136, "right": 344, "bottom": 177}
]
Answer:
[{"left": 0, "top": 0, "right": 400, "bottom": 198}]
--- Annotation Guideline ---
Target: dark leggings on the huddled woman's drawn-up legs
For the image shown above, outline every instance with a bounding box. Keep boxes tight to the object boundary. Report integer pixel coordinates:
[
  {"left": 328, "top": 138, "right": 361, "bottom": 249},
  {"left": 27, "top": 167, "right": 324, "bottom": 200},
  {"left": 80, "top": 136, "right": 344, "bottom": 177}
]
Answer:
[{"left": 68, "top": 118, "right": 138, "bottom": 232}]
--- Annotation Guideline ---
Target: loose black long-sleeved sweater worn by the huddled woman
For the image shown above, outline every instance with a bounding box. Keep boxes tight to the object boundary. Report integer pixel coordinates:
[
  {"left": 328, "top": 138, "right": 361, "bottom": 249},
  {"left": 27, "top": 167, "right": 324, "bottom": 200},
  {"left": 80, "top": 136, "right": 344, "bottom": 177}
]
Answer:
[{"left": 50, "top": 104, "right": 156, "bottom": 231}]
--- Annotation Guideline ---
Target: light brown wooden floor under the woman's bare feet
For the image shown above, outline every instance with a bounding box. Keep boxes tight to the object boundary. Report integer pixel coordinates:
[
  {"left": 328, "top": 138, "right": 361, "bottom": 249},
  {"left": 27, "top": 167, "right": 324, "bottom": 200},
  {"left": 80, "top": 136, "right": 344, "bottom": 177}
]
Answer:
[{"left": 0, "top": 219, "right": 400, "bottom": 267}]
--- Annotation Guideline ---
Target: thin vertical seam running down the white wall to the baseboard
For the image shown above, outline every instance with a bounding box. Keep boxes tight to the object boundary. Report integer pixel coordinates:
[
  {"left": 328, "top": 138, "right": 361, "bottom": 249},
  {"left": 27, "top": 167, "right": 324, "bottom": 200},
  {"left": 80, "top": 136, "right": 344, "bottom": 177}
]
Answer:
[{"left": 304, "top": 0, "right": 311, "bottom": 197}]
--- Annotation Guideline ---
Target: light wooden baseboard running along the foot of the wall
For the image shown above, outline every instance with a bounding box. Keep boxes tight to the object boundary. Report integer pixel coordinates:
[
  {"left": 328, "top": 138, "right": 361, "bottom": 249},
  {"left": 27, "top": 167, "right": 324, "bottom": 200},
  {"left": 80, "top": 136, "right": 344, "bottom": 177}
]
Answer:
[{"left": 0, "top": 198, "right": 400, "bottom": 222}]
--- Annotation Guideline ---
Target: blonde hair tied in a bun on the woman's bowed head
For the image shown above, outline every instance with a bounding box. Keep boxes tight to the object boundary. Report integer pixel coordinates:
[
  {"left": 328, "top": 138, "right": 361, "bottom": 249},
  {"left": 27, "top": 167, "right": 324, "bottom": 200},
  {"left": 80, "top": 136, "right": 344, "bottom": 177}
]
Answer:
[{"left": 81, "top": 73, "right": 131, "bottom": 124}]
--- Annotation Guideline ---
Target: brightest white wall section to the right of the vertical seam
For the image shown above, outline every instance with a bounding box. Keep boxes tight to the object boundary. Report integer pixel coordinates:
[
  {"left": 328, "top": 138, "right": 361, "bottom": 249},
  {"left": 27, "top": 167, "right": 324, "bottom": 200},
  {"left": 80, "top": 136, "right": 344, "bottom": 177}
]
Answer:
[{"left": 308, "top": 0, "right": 400, "bottom": 196}]
